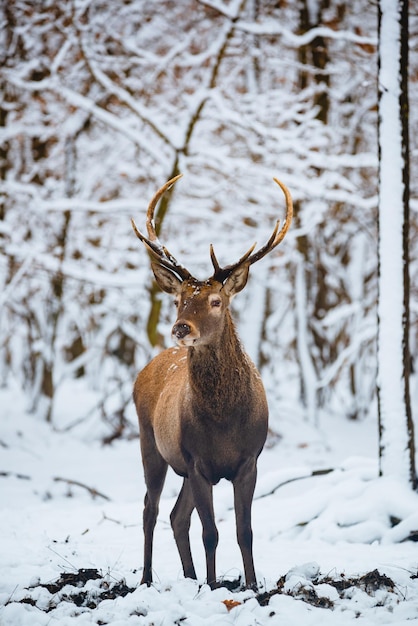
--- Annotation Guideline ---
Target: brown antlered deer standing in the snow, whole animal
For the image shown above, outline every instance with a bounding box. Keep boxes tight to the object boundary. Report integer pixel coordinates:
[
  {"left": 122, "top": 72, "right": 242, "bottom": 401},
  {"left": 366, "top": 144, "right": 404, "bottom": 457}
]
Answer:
[{"left": 131, "top": 174, "right": 293, "bottom": 589}]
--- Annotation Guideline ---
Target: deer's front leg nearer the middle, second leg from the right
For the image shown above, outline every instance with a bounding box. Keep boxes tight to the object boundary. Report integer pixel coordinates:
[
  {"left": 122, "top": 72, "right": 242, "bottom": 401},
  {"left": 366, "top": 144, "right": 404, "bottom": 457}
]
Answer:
[{"left": 189, "top": 466, "right": 218, "bottom": 589}]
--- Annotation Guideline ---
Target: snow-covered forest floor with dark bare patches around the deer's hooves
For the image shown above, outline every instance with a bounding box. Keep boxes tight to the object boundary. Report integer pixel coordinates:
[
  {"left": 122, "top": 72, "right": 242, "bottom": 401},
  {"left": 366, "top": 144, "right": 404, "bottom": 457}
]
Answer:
[{"left": 0, "top": 380, "right": 418, "bottom": 626}]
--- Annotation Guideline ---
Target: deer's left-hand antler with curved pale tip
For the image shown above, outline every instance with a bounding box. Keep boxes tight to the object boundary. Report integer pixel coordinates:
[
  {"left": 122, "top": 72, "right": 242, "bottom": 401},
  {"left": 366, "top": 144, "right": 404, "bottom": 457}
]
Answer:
[{"left": 131, "top": 174, "right": 191, "bottom": 280}]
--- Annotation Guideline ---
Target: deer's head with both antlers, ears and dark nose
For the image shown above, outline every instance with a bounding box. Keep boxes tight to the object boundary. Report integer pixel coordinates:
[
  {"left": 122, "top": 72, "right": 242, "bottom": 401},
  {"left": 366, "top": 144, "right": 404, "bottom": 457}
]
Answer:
[{"left": 131, "top": 174, "right": 293, "bottom": 347}]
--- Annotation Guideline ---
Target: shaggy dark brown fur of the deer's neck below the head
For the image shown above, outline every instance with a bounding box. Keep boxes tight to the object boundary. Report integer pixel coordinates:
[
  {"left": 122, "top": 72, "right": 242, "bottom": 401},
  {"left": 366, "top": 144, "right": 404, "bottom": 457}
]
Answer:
[{"left": 188, "top": 313, "right": 254, "bottom": 420}]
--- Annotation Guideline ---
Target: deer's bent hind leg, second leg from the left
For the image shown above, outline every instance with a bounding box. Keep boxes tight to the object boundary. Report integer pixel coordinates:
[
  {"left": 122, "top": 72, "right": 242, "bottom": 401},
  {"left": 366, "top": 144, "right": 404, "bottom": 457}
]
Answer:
[{"left": 170, "top": 478, "right": 196, "bottom": 579}]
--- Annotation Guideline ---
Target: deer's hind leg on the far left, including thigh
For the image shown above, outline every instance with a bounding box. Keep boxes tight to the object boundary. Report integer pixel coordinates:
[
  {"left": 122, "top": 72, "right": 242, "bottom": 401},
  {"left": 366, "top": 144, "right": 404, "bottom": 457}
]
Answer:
[{"left": 140, "top": 428, "right": 168, "bottom": 585}]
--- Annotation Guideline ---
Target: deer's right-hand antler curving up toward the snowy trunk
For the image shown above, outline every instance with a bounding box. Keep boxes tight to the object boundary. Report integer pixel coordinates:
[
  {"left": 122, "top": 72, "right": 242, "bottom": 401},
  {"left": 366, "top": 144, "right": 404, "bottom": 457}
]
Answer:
[{"left": 210, "top": 178, "right": 293, "bottom": 282}]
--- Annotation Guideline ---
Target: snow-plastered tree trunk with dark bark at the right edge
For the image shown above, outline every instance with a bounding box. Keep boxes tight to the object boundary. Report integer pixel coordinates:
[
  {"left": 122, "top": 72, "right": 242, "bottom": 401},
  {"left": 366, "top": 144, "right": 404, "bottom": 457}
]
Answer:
[{"left": 377, "top": 0, "right": 416, "bottom": 487}]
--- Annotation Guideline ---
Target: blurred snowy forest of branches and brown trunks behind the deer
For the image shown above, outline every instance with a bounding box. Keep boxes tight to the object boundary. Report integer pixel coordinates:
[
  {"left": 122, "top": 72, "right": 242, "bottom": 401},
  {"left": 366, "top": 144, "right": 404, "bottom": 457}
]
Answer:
[{"left": 0, "top": 0, "right": 418, "bottom": 458}]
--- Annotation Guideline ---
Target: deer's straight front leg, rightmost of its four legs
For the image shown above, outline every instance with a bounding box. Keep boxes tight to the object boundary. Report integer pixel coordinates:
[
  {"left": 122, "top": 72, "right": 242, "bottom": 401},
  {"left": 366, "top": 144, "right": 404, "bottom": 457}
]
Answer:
[{"left": 233, "top": 458, "right": 257, "bottom": 589}]
